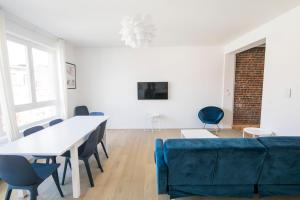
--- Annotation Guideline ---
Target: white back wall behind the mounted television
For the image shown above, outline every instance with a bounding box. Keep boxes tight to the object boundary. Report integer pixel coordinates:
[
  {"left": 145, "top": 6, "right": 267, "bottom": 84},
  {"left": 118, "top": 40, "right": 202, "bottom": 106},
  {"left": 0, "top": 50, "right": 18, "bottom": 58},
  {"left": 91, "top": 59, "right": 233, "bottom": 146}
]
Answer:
[{"left": 77, "top": 47, "right": 223, "bottom": 128}]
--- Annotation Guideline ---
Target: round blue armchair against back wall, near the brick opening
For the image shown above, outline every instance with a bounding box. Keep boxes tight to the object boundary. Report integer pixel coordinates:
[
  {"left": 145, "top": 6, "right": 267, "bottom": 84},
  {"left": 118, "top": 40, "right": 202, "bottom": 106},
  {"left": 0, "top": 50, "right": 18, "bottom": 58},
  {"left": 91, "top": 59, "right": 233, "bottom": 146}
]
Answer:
[{"left": 198, "top": 106, "right": 224, "bottom": 128}]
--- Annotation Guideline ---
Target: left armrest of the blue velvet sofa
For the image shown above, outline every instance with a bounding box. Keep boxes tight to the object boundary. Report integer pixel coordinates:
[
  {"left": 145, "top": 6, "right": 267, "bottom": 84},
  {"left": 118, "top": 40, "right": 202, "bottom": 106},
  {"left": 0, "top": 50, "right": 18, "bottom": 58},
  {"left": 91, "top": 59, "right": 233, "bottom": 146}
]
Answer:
[{"left": 154, "top": 139, "right": 168, "bottom": 194}]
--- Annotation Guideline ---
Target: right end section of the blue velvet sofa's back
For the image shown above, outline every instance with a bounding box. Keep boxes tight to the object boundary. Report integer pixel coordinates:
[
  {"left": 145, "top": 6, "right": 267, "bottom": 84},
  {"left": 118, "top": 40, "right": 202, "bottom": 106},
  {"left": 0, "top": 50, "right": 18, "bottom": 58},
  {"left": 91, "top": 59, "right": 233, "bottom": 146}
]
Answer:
[{"left": 258, "top": 137, "right": 300, "bottom": 185}]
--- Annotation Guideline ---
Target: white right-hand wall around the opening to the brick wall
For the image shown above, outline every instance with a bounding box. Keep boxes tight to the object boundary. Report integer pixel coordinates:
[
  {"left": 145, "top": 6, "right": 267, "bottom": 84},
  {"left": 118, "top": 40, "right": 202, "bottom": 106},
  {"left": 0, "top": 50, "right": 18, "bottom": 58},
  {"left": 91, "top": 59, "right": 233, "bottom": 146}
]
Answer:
[{"left": 225, "top": 7, "right": 300, "bottom": 135}]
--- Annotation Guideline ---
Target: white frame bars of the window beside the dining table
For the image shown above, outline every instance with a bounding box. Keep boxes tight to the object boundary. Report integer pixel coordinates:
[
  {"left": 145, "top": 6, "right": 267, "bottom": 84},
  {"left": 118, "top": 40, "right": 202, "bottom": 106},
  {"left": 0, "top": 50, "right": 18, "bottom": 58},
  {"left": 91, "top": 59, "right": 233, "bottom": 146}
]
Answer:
[{"left": 6, "top": 33, "right": 59, "bottom": 130}]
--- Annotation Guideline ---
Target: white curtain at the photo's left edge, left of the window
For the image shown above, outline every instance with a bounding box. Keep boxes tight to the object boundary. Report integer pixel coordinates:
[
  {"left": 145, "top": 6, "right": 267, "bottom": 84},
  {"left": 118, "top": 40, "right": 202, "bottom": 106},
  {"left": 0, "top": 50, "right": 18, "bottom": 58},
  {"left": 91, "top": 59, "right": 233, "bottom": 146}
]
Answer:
[{"left": 0, "top": 11, "right": 20, "bottom": 141}]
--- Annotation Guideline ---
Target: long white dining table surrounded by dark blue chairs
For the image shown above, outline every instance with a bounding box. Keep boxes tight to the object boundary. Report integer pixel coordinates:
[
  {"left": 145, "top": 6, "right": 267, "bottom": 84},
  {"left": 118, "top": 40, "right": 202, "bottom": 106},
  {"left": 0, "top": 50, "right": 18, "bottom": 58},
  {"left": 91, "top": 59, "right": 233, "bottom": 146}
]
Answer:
[{"left": 0, "top": 116, "right": 109, "bottom": 198}]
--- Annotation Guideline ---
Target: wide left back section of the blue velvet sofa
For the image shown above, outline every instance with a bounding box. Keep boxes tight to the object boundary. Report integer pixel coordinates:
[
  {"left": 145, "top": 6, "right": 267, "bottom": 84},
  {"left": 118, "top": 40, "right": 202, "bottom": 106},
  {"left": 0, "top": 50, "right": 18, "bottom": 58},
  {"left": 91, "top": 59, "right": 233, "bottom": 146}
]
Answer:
[{"left": 164, "top": 138, "right": 265, "bottom": 185}]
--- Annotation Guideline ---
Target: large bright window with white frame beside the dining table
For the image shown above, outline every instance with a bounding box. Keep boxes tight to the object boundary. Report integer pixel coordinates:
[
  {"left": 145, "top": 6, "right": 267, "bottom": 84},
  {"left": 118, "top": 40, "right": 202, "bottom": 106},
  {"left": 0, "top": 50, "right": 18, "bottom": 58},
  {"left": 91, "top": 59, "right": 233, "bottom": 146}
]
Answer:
[{"left": 7, "top": 36, "right": 57, "bottom": 129}]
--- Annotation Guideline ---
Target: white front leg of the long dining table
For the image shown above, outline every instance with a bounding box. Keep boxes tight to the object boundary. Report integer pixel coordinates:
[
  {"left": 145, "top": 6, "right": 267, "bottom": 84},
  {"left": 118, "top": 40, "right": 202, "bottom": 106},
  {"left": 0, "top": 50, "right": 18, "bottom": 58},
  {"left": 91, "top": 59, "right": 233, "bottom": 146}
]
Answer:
[{"left": 70, "top": 145, "right": 80, "bottom": 198}]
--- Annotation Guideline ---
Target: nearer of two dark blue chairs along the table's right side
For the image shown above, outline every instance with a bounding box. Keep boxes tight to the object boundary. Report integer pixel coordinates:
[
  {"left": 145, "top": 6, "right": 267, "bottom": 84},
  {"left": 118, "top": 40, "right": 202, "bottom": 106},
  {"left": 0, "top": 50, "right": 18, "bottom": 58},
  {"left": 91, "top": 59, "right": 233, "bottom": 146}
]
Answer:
[{"left": 61, "top": 125, "right": 103, "bottom": 187}]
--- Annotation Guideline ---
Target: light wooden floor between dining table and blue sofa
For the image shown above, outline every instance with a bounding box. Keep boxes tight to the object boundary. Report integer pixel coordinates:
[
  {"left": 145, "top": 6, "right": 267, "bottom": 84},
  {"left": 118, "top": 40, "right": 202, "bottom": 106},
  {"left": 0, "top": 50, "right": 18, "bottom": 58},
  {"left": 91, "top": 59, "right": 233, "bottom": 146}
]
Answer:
[{"left": 0, "top": 130, "right": 300, "bottom": 200}]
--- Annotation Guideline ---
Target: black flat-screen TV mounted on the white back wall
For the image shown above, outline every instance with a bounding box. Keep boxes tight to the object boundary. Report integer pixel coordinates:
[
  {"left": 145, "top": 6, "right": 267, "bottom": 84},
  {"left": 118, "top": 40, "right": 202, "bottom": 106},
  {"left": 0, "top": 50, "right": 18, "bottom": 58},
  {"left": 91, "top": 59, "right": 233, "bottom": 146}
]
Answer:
[{"left": 137, "top": 82, "right": 168, "bottom": 100}]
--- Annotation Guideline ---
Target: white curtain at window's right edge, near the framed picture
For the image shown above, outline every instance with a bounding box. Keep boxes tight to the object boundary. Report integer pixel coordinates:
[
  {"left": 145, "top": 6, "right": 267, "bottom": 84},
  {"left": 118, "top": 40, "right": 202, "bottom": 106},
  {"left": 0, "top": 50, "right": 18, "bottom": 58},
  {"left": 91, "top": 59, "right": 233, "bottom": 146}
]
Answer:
[{"left": 57, "top": 39, "right": 68, "bottom": 119}]
